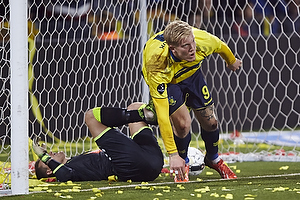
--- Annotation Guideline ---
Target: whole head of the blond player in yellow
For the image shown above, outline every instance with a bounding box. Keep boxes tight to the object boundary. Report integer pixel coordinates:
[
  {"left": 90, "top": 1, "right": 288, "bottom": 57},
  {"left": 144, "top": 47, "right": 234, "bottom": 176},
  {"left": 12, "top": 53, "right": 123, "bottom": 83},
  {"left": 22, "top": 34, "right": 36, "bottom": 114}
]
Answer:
[{"left": 164, "top": 21, "right": 196, "bottom": 62}]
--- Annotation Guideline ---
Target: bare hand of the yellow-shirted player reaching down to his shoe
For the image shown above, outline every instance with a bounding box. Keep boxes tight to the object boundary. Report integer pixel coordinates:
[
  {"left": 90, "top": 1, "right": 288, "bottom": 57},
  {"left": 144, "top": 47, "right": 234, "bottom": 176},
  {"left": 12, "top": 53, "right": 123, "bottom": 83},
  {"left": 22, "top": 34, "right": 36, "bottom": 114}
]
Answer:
[{"left": 169, "top": 153, "right": 185, "bottom": 181}]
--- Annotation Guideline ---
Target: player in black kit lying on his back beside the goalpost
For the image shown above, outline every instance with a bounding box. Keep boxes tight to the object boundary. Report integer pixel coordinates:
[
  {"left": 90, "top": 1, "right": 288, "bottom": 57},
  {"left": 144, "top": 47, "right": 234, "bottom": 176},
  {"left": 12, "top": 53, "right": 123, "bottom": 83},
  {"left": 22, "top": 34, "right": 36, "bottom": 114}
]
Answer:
[{"left": 33, "top": 103, "right": 164, "bottom": 182}]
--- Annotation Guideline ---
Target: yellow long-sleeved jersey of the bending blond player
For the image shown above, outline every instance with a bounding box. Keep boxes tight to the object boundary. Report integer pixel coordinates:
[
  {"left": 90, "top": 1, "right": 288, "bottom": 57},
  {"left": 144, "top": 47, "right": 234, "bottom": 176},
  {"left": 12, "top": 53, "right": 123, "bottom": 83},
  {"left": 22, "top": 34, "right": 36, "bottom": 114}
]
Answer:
[{"left": 142, "top": 28, "right": 236, "bottom": 154}]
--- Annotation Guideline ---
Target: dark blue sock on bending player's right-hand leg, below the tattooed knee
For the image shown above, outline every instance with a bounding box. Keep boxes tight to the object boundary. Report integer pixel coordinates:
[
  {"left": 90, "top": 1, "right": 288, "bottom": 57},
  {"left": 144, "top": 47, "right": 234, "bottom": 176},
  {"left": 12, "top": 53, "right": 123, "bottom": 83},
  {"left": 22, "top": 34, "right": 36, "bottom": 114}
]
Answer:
[{"left": 201, "top": 128, "right": 219, "bottom": 160}]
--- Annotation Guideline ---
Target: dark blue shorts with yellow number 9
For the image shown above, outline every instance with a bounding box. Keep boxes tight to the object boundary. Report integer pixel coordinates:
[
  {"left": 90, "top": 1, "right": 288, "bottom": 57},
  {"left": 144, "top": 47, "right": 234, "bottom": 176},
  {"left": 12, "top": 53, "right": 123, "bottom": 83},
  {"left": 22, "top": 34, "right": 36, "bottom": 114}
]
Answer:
[{"left": 167, "top": 69, "right": 214, "bottom": 115}]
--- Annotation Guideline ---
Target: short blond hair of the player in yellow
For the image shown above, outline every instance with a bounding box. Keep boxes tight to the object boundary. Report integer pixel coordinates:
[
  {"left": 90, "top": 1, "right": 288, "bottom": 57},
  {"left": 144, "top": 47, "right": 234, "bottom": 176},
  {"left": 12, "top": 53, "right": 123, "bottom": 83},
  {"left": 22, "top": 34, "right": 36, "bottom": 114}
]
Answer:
[{"left": 164, "top": 20, "right": 192, "bottom": 46}]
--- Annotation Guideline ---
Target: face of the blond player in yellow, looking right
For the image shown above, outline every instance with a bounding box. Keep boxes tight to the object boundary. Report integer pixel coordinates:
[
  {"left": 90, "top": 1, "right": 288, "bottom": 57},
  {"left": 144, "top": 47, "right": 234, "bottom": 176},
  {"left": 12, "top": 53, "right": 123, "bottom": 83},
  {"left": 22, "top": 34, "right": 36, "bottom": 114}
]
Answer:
[{"left": 170, "top": 33, "right": 196, "bottom": 62}]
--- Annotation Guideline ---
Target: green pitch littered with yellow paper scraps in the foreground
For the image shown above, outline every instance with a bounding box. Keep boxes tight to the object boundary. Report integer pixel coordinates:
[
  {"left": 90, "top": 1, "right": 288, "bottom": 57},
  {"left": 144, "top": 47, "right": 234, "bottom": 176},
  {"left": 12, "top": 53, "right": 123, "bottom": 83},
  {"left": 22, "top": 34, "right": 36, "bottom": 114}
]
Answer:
[{"left": 0, "top": 162, "right": 300, "bottom": 200}]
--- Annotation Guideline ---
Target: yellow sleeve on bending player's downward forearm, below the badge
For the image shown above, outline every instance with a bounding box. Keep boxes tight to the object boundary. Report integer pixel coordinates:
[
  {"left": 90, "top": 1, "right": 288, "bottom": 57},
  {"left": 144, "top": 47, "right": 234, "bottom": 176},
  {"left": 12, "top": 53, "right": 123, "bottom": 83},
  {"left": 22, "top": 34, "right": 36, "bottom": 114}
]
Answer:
[{"left": 152, "top": 98, "right": 177, "bottom": 154}]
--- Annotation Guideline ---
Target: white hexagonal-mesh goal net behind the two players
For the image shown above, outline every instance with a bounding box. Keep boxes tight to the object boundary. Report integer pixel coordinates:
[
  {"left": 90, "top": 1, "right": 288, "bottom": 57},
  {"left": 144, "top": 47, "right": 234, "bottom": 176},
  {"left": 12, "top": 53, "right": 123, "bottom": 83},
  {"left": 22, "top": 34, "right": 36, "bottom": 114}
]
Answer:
[{"left": 0, "top": 0, "right": 300, "bottom": 188}]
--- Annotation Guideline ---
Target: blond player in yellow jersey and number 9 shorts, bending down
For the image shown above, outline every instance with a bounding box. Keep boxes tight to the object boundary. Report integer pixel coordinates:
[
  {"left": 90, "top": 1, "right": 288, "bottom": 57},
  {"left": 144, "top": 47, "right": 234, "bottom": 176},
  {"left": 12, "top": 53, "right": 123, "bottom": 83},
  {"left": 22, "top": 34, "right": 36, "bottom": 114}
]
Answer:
[{"left": 143, "top": 21, "right": 242, "bottom": 181}]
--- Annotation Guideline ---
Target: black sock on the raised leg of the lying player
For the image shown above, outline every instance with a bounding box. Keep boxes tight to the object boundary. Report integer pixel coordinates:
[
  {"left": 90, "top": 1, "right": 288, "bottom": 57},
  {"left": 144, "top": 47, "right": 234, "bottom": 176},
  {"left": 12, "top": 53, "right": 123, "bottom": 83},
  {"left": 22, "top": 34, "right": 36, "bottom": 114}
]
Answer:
[{"left": 100, "top": 107, "right": 143, "bottom": 127}]
